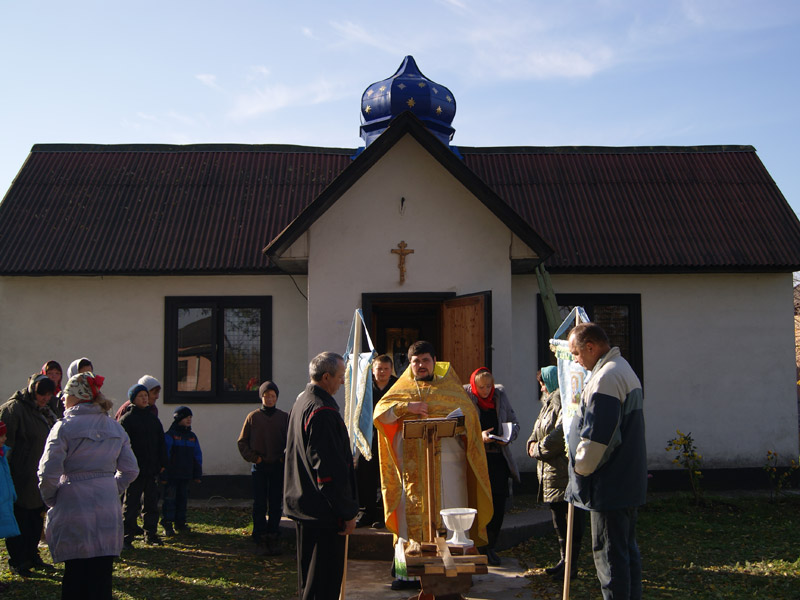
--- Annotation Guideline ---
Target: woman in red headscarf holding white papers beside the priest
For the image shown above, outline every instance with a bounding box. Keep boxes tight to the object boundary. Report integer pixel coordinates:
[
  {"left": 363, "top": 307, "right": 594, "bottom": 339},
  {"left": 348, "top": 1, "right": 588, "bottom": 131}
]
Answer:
[{"left": 464, "top": 367, "right": 519, "bottom": 565}]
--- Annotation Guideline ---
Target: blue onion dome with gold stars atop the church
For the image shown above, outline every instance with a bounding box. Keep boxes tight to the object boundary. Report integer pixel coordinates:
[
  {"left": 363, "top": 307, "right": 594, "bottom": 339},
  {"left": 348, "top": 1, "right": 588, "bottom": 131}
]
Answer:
[{"left": 361, "top": 56, "right": 456, "bottom": 146}]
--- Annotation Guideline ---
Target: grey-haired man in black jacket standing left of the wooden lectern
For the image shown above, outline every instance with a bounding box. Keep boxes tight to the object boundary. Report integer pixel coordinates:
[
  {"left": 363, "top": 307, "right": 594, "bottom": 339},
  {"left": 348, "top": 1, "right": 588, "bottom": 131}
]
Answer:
[{"left": 283, "top": 352, "right": 358, "bottom": 600}]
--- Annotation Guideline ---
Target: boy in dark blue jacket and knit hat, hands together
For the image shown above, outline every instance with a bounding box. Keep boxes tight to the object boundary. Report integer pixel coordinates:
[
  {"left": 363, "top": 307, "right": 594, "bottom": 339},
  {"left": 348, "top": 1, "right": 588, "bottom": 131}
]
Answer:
[{"left": 161, "top": 406, "right": 203, "bottom": 536}]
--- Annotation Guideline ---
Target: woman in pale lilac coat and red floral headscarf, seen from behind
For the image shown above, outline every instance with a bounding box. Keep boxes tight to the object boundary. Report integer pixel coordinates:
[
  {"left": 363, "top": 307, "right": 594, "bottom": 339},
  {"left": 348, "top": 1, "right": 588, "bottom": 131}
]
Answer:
[{"left": 39, "top": 372, "right": 139, "bottom": 600}]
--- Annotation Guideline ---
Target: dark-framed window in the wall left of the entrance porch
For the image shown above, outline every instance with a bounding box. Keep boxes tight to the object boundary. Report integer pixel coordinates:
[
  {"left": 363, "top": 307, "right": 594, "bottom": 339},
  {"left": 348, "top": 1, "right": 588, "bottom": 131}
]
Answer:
[{"left": 164, "top": 296, "right": 272, "bottom": 404}]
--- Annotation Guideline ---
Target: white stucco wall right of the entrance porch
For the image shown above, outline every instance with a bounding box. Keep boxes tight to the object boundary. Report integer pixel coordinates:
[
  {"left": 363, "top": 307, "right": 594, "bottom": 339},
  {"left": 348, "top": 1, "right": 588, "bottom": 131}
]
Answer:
[{"left": 512, "top": 273, "right": 798, "bottom": 470}]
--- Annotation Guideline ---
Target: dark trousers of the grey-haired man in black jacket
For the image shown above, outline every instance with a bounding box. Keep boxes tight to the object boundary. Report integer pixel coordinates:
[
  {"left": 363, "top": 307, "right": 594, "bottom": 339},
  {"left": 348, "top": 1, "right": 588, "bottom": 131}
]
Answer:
[{"left": 296, "top": 521, "right": 346, "bottom": 600}]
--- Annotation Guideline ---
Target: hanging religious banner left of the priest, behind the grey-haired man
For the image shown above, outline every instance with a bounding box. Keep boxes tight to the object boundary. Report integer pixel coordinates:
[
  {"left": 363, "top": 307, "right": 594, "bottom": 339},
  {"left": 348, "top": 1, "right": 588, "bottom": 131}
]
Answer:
[{"left": 343, "top": 308, "right": 378, "bottom": 460}]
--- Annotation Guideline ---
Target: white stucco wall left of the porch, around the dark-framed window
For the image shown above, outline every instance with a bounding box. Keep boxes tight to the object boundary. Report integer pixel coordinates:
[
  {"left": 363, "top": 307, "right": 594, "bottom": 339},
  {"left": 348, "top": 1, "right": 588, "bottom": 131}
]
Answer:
[{"left": 0, "top": 276, "right": 308, "bottom": 475}]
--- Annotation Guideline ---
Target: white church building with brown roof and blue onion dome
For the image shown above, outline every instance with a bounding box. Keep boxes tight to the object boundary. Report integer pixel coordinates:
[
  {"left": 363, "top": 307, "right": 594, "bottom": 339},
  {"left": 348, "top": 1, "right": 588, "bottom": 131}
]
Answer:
[{"left": 0, "top": 56, "right": 800, "bottom": 488}]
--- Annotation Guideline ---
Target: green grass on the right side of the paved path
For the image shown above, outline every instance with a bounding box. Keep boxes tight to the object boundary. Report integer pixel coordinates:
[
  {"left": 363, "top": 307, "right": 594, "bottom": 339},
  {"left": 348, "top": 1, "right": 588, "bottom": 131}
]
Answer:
[{"left": 512, "top": 494, "right": 800, "bottom": 600}]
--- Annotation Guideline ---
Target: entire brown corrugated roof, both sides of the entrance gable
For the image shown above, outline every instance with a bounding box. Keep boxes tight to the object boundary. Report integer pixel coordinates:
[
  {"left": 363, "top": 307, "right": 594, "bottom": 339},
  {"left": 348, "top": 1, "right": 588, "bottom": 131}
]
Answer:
[{"left": 0, "top": 144, "right": 800, "bottom": 275}]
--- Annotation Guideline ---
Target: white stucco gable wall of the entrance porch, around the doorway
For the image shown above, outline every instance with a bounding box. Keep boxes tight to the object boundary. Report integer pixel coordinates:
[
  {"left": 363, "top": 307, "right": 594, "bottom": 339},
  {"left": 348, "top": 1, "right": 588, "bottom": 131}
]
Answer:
[{"left": 308, "top": 136, "right": 511, "bottom": 386}]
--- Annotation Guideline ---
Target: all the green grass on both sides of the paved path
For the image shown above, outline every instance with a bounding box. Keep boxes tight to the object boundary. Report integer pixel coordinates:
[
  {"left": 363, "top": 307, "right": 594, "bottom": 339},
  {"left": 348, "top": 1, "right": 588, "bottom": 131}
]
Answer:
[{"left": 0, "top": 493, "right": 800, "bottom": 600}]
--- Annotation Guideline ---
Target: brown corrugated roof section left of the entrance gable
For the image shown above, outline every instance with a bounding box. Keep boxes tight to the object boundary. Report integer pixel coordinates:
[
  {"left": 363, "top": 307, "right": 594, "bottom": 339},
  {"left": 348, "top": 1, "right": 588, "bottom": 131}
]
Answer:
[{"left": 0, "top": 144, "right": 353, "bottom": 275}]
